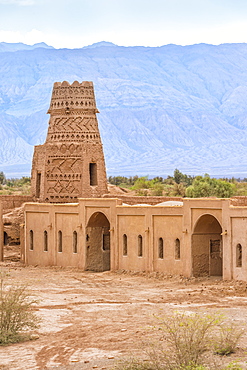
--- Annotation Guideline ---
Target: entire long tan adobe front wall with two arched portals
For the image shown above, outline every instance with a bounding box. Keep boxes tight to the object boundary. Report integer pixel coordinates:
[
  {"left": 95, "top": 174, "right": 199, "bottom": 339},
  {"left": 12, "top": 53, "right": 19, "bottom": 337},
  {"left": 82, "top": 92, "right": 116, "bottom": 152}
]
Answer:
[{"left": 22, "top": 198, "right": 247, "bottom": 281}]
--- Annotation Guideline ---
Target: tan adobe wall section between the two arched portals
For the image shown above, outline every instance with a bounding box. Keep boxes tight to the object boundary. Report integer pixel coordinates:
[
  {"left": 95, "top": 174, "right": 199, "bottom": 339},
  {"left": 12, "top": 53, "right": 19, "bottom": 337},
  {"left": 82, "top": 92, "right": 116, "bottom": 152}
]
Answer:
[{"left": 114, "top": 206, "right": 183, "bottom": 275}]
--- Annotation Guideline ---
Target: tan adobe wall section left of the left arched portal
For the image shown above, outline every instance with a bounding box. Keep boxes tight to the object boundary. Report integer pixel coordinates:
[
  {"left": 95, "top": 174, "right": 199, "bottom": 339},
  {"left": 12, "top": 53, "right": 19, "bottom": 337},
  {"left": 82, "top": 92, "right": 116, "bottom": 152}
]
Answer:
[{"left": 24, "top": 203, "right": 79, "bottom": 268}]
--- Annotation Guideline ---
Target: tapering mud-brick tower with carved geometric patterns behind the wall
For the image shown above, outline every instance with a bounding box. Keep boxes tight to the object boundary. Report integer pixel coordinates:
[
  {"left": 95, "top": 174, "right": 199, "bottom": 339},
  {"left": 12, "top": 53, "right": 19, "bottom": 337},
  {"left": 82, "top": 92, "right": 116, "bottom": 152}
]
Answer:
[{"left": 31, "top": 81, "right": 107, "bottom": 203}]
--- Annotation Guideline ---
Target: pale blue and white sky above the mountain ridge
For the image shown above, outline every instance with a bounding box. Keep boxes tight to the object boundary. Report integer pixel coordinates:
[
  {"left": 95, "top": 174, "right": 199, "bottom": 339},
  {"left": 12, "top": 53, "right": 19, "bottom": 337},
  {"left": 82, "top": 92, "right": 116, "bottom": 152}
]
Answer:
[{"left": 0, "top": 0, "right": 247, "bottom": 48}]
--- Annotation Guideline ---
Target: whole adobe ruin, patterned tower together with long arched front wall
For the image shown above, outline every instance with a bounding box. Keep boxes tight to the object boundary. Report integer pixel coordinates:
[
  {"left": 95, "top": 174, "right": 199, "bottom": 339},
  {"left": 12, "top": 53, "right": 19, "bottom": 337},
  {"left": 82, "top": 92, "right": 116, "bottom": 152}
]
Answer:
[{"left": 1, "top": 81, "right": 247, "bottom": 281}]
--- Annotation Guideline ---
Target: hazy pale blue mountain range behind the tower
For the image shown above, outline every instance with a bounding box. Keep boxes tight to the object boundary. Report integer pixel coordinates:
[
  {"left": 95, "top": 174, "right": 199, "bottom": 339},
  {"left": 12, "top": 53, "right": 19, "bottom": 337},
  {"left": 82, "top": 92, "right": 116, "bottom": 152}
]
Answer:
[{"left": 0, "top": 42, "right": 247, "bottom": 177}]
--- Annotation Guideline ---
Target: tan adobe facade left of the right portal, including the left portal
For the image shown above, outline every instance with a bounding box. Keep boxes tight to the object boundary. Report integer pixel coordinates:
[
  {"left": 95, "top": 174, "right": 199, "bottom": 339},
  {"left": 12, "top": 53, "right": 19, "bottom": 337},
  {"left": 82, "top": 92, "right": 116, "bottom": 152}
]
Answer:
[{"left": 25, "top": 198, "right": 187, "bottom": 274}]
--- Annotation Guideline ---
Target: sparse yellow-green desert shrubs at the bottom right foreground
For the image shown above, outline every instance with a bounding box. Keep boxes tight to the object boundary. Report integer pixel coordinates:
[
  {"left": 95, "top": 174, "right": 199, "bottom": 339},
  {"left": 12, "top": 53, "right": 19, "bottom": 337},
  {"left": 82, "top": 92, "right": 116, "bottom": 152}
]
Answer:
[{"left": 117, "top": 312, "right": 243, "bottom": 370}]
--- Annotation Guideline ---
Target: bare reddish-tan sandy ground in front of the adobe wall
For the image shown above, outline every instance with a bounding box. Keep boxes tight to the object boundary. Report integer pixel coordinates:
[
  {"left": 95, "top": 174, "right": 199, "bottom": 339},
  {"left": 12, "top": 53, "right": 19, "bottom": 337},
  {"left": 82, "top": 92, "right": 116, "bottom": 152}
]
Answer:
[{"left": 0, "top": 250, "right": 247, "bottom": 370}]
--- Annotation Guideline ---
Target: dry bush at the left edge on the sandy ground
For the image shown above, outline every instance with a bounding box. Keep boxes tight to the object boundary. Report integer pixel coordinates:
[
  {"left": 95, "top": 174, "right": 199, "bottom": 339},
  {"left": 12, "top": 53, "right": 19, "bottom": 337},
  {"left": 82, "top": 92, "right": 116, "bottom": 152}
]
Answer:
[{"left": 0, "top": 279, "right": 39, "bottom": 345}]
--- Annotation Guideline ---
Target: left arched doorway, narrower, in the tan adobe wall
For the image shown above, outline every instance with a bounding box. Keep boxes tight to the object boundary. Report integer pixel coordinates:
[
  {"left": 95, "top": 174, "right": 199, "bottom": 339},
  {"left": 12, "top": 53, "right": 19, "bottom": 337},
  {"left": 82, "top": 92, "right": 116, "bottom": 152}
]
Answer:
[{"left": 85, "top": 212, "right": 110, "bottom": 271}]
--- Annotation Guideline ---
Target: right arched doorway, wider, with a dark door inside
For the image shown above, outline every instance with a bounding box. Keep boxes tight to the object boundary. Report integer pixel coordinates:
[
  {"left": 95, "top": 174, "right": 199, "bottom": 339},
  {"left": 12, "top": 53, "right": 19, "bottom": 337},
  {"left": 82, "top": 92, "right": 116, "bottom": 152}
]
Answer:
[{"left": 191, "top": 214, "right": 222, "bottom": 276}]
